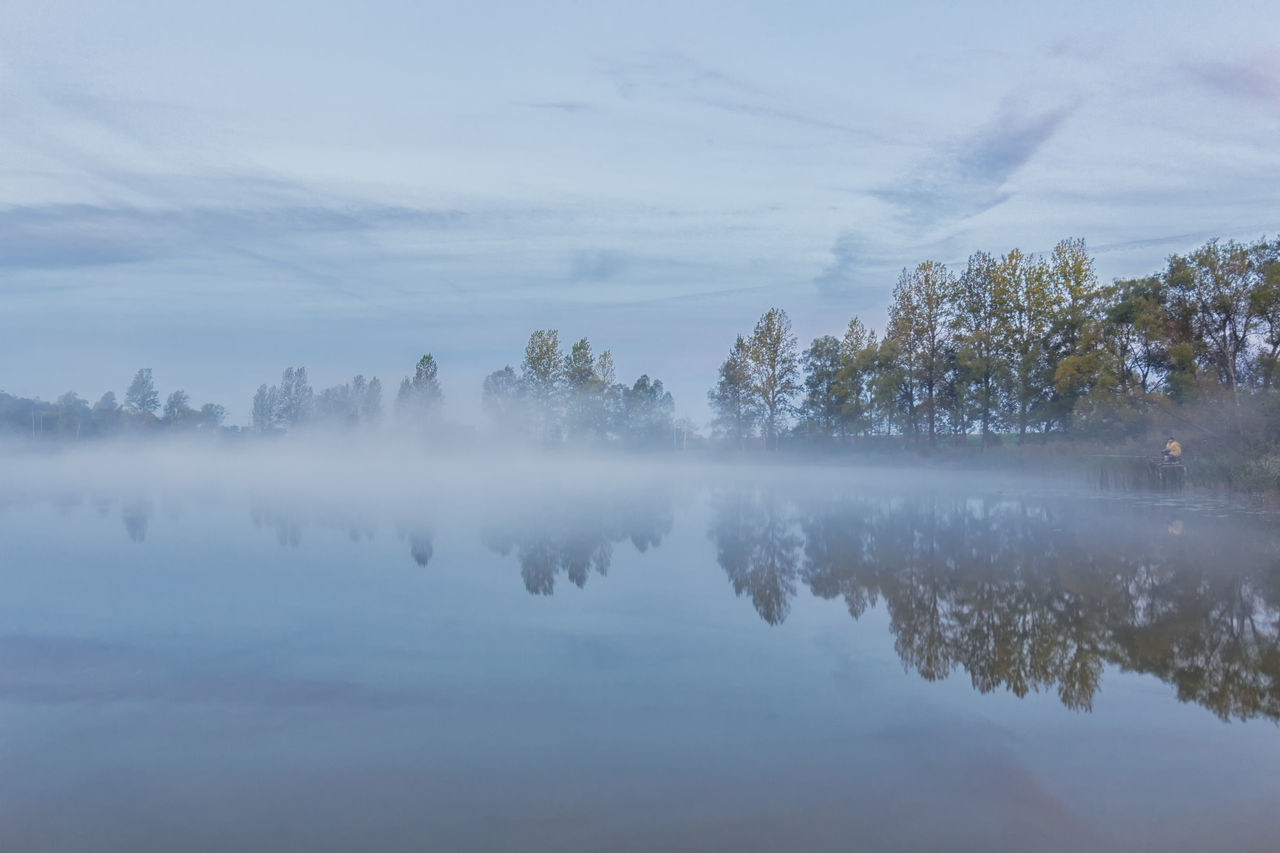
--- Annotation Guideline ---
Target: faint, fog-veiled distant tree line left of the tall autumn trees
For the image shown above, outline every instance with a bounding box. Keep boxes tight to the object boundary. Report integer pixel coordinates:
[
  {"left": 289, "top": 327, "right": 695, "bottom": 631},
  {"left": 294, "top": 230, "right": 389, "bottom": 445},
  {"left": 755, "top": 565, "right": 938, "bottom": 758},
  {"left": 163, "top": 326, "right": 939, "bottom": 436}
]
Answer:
[{"left": 0, "top": 329, "right": 694, "bottom": 447}]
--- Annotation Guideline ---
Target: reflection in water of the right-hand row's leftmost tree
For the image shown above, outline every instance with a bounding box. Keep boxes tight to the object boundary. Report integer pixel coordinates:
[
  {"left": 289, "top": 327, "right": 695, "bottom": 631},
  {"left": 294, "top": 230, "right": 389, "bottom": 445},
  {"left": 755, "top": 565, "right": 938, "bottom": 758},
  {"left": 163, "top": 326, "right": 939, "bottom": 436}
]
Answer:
[{"left": 709, "top": 489, "right": 803, "bottom": 625}]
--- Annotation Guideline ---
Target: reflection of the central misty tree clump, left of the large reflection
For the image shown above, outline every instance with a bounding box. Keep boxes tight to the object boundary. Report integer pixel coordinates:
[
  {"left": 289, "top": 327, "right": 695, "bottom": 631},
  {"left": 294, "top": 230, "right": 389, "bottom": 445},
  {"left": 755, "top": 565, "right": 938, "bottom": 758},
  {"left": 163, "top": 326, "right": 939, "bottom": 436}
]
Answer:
[{"left": 483, "top": 494, "right": 672, "bottom": 596}]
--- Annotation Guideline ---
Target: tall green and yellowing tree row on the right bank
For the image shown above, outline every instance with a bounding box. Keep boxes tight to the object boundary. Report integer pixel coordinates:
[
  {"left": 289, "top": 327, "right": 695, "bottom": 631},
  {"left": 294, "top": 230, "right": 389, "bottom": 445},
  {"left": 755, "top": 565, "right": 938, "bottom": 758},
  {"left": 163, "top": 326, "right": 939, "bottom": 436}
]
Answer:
[{"left": 708, "top": 238, "right": 1280, "bottom": 447}]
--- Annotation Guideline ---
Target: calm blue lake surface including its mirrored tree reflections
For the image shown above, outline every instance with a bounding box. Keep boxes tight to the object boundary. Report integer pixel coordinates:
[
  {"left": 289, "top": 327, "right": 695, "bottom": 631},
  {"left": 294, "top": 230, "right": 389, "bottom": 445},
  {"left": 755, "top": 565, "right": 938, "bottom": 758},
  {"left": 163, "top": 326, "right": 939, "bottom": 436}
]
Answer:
[{"left": 0, "top": 471, "right": 1280, "bottom": 850}]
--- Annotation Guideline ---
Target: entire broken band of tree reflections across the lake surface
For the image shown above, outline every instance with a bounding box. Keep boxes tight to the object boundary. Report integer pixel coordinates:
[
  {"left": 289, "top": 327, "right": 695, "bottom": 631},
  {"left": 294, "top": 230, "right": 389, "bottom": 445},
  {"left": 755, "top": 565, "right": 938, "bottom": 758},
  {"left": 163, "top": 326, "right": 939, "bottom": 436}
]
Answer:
[{"left": 22, "top": 485, "right": 1280, "bottom": 721}]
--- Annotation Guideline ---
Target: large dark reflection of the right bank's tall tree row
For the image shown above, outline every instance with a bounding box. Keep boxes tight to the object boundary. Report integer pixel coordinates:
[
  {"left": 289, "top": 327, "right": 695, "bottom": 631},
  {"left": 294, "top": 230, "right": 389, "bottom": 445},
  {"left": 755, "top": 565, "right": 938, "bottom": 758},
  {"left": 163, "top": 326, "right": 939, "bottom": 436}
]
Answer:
[{"left": 712, "top": 494, "right": 1280, "bottom": 720}]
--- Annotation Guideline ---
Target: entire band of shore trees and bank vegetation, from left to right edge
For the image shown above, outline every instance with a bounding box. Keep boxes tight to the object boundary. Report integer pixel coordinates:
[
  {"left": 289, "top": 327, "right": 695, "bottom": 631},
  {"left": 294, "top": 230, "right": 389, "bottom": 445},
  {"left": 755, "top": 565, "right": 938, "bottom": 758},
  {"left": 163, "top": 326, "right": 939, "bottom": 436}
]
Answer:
[{"left": 0, "top": 240, "right": 1280, "bottom": 489}]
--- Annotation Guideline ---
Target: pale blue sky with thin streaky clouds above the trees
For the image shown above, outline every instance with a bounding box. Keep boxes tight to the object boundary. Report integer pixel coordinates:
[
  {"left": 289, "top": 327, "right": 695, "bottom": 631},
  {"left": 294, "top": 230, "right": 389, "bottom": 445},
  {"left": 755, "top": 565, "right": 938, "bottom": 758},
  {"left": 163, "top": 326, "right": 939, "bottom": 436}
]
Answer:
[{"left": 0, "top": 0, "right": 1280, "bottom": 424}]
